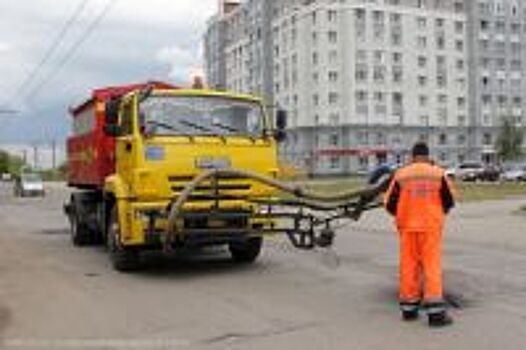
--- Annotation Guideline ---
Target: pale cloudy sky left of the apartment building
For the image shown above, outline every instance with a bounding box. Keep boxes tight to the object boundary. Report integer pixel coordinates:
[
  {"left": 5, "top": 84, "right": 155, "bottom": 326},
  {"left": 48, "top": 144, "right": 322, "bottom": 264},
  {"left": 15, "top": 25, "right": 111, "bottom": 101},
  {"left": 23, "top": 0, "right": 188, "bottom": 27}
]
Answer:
[{"left": 0, "top": 0, "right": 218, "bottom": 147}]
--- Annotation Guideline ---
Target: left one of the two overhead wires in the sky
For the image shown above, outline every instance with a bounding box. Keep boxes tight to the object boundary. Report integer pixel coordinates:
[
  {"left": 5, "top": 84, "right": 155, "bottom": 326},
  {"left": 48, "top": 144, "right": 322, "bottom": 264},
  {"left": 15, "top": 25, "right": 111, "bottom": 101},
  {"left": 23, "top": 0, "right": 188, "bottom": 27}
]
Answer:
[{"left": 8, "top": 0, "right": 90, "bottom": 101}]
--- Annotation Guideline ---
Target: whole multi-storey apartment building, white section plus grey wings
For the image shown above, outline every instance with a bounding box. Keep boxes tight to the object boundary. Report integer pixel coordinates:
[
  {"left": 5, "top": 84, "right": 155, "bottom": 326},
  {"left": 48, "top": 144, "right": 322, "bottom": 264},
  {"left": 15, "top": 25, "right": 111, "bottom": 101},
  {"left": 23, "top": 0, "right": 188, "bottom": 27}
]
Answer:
[{"left": 207, "top": 0, "right": 526, "bottom": 174}]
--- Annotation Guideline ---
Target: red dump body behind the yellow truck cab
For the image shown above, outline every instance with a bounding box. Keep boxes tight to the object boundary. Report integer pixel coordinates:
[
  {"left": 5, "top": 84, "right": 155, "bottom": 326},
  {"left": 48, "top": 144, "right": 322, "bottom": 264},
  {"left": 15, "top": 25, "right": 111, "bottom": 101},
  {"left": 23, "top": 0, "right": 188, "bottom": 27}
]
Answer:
[{"left": 66, "top": 82, "right": 175, "bottom": 189}]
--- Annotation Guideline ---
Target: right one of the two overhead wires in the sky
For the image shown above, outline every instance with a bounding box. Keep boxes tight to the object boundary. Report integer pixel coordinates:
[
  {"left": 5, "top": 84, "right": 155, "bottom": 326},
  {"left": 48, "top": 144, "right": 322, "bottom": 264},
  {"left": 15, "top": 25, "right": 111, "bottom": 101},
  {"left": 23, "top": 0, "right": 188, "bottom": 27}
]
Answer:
[{"left": 25, "top": 0, "right": 117, "bottom": 103}]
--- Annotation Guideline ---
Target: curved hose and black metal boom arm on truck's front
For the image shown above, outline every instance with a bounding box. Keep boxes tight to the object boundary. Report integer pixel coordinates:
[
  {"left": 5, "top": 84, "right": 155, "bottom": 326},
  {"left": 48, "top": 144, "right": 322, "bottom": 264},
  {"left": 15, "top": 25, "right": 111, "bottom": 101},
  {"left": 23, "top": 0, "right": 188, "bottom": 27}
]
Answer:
[{"left": 164, "top": 169, "right": 389, "bottom": 250}]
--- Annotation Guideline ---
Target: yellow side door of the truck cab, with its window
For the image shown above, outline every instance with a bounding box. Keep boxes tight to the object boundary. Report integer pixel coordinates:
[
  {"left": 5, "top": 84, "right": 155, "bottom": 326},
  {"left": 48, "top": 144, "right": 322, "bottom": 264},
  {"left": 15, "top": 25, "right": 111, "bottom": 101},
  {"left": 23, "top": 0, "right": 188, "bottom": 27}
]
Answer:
[{"left": 116, "top": 99, "right": 137, "bottom": 185}]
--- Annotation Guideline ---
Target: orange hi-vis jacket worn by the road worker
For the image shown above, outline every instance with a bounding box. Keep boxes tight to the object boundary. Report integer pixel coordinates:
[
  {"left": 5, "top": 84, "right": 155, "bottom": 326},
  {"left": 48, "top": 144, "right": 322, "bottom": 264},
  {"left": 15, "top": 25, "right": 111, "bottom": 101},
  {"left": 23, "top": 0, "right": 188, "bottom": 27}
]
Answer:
[{"left": 385, "top": 161, "right": 455, "bottom": 232}]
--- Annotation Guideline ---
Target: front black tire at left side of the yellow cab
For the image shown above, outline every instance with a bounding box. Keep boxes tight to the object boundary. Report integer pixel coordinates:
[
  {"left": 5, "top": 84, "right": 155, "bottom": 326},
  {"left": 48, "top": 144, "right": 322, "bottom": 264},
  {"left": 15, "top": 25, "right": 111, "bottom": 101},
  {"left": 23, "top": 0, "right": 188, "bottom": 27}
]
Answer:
[{"left": 106, "top": 205, "right": 141, "bottom": 272}]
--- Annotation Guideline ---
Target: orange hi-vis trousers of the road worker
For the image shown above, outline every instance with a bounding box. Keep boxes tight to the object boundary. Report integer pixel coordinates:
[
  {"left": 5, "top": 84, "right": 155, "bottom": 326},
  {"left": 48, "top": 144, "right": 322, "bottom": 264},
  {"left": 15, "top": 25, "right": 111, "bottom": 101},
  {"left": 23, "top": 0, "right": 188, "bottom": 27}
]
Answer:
[{"left": 399, "top": 229, "right": 443, "bottom": 303}]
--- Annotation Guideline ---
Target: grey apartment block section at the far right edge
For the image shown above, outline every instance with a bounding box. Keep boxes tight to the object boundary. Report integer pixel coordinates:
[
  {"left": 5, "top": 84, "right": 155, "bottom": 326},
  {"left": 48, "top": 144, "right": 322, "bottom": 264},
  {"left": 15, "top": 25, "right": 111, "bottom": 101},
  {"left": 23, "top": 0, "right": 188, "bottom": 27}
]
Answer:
[{"left": 467, "top": 0, "right": 526, "bottom": 161}]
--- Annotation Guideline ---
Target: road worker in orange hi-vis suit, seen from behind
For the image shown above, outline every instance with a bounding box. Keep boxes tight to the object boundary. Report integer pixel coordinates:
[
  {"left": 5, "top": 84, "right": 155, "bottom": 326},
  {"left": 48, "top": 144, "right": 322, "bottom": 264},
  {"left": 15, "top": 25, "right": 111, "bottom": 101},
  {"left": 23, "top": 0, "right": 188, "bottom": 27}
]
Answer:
[{"left": 385, "top": 142, "right": 455, "bottom": 327}]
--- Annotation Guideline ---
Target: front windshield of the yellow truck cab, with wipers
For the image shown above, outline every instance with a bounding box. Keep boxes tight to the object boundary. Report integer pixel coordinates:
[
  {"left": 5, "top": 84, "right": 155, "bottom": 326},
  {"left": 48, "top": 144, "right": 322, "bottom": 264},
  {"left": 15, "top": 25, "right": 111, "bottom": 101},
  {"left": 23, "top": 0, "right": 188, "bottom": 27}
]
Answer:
[{"left": 139, "top": 96, "right": 263, "bottom": 137}]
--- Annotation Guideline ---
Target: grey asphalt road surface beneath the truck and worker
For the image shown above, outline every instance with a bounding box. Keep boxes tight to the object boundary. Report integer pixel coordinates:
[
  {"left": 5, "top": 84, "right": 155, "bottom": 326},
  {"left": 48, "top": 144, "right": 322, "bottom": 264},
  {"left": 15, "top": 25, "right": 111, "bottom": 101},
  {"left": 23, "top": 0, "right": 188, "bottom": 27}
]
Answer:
[{"left": 0, "top": 184, "right": 526, "bottom": 350}]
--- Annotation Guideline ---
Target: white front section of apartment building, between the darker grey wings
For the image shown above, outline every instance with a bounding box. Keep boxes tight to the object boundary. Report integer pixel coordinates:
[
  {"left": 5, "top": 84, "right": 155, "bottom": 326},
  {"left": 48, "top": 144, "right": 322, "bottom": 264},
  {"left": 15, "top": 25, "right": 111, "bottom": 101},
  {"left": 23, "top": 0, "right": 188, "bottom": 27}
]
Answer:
[{"left": 273, "top": 0, "right": 468, "bottom": 173}]
